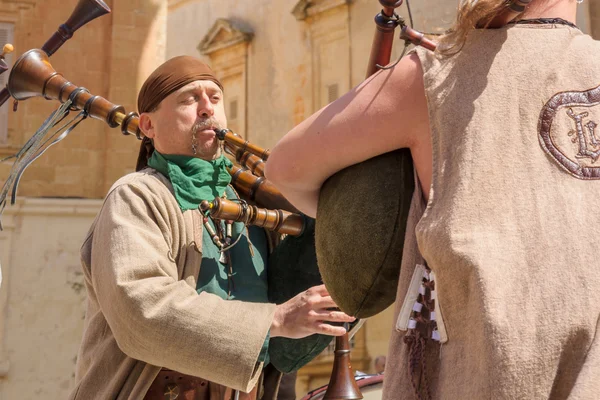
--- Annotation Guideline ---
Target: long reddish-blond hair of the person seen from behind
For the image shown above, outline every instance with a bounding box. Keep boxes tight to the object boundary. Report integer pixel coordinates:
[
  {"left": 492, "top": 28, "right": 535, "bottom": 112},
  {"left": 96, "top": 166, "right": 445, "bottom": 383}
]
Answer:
[{"left": 439, "top": 0, "right": 510, "bottom": 55}]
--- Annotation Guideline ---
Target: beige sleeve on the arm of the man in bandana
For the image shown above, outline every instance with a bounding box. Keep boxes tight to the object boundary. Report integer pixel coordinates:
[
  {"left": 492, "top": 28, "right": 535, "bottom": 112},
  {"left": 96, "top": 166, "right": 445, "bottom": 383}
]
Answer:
[{"left": 91, "top": 184, "right": 275, "bottom": 391}]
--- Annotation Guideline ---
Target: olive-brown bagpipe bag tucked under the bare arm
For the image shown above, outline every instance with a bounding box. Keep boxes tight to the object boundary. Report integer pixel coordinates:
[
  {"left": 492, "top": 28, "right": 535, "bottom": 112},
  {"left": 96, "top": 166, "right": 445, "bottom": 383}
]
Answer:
[{"left": 315, "top": 149, "right": 415, "bottom": 318}]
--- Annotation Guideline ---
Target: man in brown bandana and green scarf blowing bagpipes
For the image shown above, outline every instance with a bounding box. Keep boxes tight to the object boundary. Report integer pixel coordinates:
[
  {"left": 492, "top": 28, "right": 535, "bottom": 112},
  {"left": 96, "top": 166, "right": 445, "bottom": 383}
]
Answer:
[{"left": 71, "top": 56, "right": 354, "bottom": 400}]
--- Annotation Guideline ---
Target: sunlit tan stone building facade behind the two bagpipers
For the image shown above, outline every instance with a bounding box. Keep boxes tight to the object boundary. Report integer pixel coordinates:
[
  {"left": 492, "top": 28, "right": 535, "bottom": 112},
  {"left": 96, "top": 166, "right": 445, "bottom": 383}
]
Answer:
[{"left": 0, "top": 0, "right": 600, "bottom": 399}]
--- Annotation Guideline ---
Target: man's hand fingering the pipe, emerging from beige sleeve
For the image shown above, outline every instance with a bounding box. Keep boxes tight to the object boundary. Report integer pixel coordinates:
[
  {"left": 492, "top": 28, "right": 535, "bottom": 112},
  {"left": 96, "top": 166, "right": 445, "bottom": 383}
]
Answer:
[{"left": 271, "top": 285, "right": 355, "bottom": 339}]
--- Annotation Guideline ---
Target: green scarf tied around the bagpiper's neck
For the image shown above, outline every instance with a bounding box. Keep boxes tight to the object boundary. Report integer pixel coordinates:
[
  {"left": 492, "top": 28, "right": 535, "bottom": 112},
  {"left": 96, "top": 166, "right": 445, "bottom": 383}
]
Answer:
[{"left": 148, "top": 150, "right": 233, "bottom": 211}]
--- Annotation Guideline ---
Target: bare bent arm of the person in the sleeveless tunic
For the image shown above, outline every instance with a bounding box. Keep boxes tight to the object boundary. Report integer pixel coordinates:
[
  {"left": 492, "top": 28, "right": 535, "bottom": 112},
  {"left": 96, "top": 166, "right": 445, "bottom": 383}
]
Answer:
[{"left": 265, "top": 54, "right": 428, "bottom": 217}]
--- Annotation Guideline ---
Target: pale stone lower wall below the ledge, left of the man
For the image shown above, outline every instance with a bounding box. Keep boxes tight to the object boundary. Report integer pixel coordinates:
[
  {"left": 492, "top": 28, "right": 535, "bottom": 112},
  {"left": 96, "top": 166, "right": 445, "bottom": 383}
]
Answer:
[{"left": 0, "top": 198, "right": 101, "bottom": 400}]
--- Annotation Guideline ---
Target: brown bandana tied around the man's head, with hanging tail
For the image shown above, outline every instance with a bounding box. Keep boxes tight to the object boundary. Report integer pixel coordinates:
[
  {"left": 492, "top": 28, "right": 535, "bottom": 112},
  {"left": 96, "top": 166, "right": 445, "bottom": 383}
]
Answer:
[{"left": 136, "top": 56, "right": 223, "bottom": 171}]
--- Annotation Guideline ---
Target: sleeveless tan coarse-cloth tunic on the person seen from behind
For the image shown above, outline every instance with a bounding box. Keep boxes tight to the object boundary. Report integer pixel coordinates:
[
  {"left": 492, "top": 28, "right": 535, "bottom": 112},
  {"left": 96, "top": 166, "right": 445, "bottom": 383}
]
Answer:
[{"left": 384, "top": 25, "right": 600, "bottom": 400}]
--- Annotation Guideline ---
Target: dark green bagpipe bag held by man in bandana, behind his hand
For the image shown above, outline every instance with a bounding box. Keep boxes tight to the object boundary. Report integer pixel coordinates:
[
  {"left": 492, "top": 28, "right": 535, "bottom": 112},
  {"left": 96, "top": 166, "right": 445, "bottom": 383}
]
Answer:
[{"left": 267, "top": 216, "right": 333, "bottom": 373}]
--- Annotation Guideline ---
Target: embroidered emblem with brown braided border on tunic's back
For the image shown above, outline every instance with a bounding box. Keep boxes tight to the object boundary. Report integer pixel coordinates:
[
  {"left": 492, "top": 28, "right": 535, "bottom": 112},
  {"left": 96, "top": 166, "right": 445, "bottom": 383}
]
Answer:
[{"left": 538, "top": 86, "right": 600, "bottom": 179}]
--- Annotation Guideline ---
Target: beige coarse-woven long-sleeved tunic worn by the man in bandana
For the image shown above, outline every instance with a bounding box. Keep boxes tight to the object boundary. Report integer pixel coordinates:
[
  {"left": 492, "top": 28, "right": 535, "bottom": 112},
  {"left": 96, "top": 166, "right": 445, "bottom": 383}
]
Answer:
[{"left": 70, "top": 169, "right": 275, "bottom": 400}]
